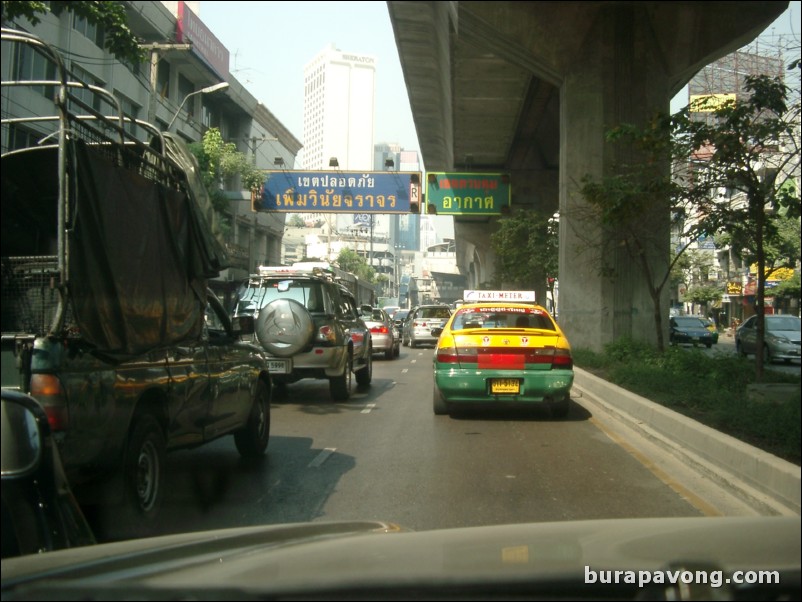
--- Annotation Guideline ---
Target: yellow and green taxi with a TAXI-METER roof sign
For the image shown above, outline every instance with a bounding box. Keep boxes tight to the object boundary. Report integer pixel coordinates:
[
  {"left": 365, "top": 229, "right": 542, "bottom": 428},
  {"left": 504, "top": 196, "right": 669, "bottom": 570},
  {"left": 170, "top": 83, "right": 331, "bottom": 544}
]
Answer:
[{"left": 432, "top": 291, "right": 574, "bottom": 417}]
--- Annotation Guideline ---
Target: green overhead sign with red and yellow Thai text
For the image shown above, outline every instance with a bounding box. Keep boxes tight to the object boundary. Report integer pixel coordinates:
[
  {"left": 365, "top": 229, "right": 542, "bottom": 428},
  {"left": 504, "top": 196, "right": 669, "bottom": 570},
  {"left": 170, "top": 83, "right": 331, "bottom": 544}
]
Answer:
[{"left": 426, "top": 173, "right": 512, "bottom": 215}]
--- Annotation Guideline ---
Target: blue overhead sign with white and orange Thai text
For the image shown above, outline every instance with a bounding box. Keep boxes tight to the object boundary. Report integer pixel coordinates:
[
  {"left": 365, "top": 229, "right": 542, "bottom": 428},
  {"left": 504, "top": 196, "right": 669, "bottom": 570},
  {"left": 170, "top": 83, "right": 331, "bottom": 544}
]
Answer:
[{"left": 258, "top": 171, "right": 421, "bottom": 213}]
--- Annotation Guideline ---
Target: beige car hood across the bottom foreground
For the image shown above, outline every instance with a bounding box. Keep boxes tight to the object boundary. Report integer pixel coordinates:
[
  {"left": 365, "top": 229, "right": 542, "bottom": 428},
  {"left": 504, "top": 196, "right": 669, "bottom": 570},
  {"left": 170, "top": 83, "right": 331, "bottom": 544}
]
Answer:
[{"left": 2, "top": 516, "right": 801, "bottom": 600}]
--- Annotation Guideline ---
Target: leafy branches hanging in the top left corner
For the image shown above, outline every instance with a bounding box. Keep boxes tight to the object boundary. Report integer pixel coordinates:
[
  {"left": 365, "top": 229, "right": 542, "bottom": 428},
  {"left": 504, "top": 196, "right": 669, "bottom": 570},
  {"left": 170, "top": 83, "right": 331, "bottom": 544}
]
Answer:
[{"left": 2, "top": 0, "right": 145, "bottom": 65}]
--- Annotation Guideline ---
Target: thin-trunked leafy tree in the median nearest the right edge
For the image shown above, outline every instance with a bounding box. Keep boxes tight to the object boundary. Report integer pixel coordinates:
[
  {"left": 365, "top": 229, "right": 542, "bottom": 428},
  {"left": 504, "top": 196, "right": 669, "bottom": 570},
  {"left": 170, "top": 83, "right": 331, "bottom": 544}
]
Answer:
[{"left": 676, "top": 75, "right": 800, "bottom": 380}]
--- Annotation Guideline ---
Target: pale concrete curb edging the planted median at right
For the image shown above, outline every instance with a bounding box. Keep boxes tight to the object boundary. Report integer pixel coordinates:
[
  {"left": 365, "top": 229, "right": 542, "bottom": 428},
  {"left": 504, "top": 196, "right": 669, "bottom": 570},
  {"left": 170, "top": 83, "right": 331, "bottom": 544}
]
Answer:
[{"left": 574, "top": 366, "right": 802, "bottom": 515}]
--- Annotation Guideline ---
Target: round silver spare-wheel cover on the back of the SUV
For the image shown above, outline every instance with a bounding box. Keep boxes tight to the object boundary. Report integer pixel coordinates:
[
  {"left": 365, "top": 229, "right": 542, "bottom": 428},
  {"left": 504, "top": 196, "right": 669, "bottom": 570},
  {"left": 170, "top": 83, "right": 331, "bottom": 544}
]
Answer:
[{"left": 256, "top": 299, "right": 315, "bottom": 357}]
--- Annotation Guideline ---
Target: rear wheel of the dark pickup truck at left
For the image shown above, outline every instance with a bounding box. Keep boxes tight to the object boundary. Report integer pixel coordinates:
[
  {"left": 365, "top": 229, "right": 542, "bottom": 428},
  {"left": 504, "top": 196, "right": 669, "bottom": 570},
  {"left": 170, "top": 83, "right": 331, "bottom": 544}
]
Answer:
[{"left": 123, "top": 413, "right": 166, "bottom": 520}]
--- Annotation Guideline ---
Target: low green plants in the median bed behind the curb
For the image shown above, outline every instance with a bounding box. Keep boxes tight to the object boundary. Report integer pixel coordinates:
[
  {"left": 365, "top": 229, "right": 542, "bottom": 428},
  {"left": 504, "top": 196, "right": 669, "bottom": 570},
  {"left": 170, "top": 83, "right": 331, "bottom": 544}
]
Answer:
[{"left": 573, "top": 339, "right": 802, "bottom": 464}]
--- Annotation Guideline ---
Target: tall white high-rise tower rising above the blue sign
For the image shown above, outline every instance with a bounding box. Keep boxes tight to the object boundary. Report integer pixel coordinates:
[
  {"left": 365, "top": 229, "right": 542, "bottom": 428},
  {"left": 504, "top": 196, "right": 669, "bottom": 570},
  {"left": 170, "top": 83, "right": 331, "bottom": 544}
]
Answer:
[{"left": 303, "top": 45, "right": 376, "bottom": 171}]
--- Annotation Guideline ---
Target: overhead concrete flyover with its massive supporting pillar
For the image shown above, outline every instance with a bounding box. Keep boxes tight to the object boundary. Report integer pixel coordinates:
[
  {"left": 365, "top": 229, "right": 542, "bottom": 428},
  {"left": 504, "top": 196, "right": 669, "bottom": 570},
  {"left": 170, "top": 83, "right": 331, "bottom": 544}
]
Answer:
[{"left": 387, "top": 1, "right": 788, "bottom": 350}]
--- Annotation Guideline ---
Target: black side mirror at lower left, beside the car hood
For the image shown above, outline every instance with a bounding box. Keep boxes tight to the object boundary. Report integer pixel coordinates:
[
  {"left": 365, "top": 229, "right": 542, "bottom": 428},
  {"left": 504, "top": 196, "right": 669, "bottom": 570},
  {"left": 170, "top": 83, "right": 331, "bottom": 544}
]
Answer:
[{"left": 0, "top": 389, "right": 96, "bottom": 559}]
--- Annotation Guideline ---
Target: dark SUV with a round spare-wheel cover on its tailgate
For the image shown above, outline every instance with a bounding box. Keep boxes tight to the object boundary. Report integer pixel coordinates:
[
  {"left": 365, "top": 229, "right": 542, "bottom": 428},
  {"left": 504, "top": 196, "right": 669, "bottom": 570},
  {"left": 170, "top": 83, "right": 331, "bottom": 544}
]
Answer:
[{"left": 230, "top": 262, "right": 373, "bottom": 401}]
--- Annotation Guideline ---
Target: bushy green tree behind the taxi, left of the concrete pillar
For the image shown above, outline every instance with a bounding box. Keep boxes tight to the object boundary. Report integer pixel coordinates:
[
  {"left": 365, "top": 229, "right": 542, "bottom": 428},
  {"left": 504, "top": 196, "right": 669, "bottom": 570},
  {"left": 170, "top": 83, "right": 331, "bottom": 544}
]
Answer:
[{"left": 490, "top": 209, "right": 559, "bottom": 312}]
